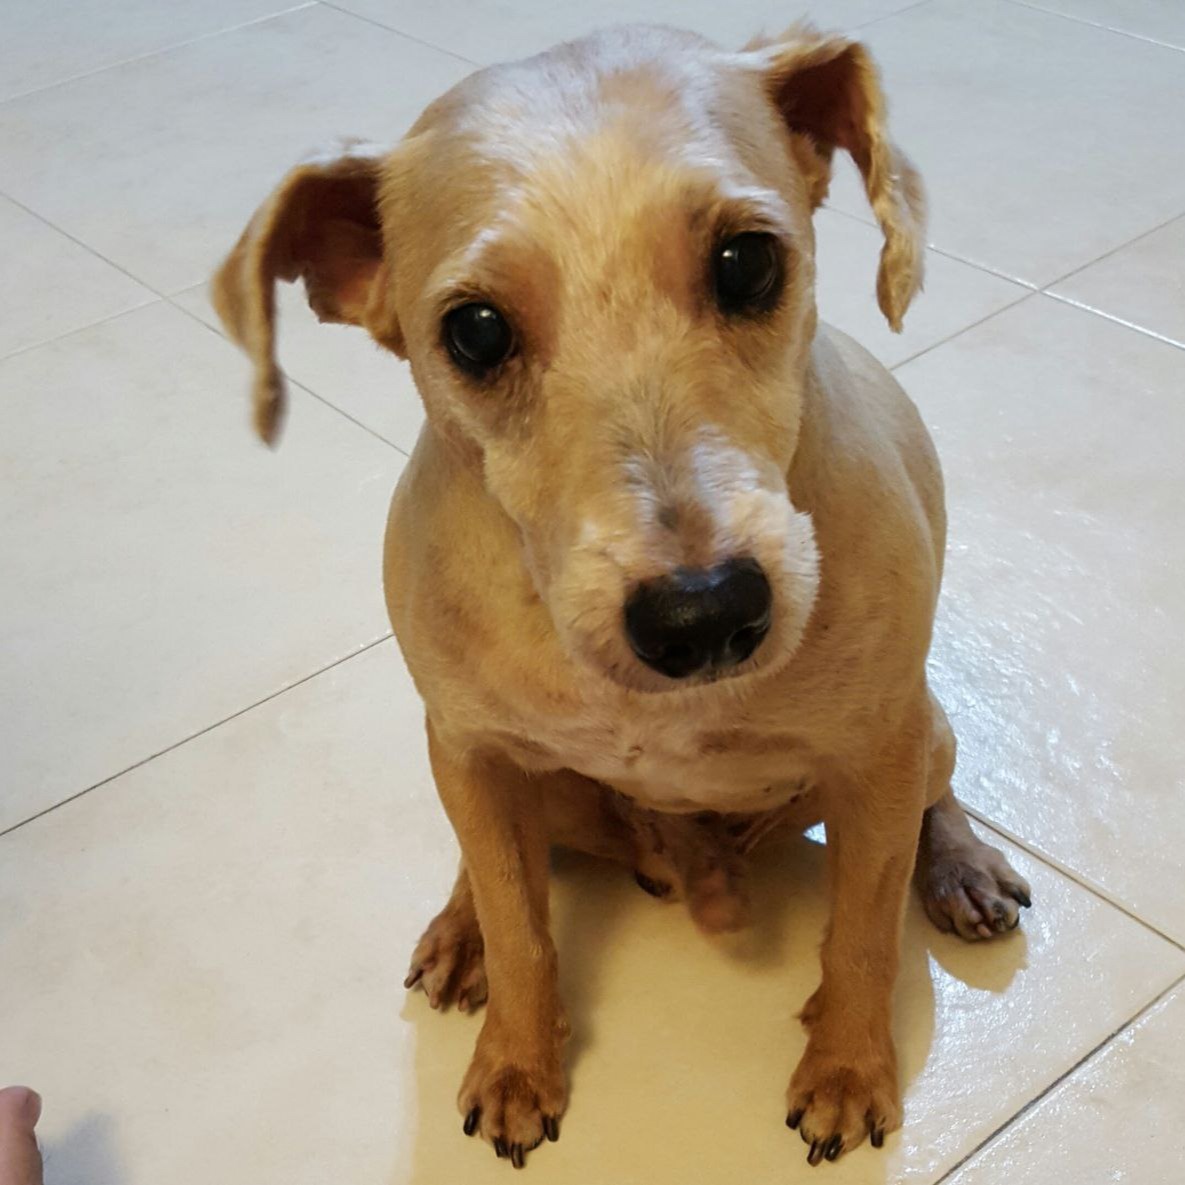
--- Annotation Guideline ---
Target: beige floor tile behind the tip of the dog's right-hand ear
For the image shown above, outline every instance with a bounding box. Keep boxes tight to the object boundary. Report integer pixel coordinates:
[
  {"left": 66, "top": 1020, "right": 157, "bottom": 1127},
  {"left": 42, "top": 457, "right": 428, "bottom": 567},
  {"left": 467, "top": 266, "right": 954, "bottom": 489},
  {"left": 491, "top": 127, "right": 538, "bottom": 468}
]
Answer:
[{"left": 815, "top": 210, "right": 1029, "bottom": 366}]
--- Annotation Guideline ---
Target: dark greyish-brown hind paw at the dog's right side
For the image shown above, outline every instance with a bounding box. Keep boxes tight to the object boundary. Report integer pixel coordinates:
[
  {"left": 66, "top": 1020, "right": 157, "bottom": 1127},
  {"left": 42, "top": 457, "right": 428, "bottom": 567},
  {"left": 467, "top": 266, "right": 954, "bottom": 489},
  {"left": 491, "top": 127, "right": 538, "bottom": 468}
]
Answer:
[{"left": 917, "top": 844, "right": 1032, "bottom": 942}]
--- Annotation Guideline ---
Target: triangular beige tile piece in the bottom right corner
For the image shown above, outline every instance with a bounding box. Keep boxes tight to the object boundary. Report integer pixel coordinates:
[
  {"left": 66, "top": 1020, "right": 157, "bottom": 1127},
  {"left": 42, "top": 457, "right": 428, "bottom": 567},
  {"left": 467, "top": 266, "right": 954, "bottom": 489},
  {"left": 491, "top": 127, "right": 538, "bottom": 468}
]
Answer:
[{"left": 949, "top": 988, "right": 1185, "bottom": 1185}]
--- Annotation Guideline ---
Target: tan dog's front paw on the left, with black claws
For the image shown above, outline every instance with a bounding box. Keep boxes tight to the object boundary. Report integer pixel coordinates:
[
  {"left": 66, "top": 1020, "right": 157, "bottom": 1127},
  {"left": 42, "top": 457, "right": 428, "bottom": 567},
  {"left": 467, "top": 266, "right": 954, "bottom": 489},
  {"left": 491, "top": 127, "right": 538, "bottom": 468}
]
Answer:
[{"left": 457, "top": 1031, "right": 568, "bottom": 1168}]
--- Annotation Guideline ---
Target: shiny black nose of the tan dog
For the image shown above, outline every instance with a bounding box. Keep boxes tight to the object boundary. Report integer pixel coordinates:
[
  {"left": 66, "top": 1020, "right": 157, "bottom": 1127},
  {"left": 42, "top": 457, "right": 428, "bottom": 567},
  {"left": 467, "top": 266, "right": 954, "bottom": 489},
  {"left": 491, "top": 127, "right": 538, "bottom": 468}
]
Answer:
[{"left": 626, "top": 559, "right": 773, "bottom": 679}]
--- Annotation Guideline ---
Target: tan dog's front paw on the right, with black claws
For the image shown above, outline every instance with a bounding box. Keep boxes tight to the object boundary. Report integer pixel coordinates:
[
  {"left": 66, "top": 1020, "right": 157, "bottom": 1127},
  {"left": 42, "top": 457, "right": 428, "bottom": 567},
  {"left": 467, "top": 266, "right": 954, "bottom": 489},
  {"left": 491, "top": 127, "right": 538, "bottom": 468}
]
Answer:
[{"left": 786, "top": 1038, "right": 902, "bottom": 1165}]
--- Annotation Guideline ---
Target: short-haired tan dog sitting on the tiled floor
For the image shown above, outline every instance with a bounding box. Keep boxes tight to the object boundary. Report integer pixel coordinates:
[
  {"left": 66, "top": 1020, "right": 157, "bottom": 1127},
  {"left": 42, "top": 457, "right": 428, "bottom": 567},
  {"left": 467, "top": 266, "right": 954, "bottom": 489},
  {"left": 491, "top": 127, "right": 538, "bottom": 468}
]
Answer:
[{"left": 214, "top": 27, "right": 1029, "bottom": 1167}]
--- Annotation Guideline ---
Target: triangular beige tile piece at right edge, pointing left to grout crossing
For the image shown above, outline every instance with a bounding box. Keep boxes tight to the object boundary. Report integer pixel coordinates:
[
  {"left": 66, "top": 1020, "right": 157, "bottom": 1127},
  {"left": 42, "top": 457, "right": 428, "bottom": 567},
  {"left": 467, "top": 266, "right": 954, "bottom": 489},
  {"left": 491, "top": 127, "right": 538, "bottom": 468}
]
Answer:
[{"left": 1050, "top": 213, "right": 1185, "bottom": 346}]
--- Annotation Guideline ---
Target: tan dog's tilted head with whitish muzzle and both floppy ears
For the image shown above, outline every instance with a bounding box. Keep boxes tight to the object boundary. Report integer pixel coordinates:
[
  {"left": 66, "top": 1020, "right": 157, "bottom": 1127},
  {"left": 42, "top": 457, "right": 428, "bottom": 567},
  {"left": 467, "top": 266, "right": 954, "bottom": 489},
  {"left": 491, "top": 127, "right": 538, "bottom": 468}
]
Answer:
[{"left": 214, "top": 20, "right": 922, "bottom": 690}]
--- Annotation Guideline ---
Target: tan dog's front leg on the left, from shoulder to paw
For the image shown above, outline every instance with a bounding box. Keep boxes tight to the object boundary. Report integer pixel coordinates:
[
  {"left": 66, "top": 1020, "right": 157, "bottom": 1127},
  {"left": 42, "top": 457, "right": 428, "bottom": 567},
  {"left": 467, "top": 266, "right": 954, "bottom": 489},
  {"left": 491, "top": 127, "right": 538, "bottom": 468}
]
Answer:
[{"left": 428, "top": 723, "right": 568, "bottom": 1167}]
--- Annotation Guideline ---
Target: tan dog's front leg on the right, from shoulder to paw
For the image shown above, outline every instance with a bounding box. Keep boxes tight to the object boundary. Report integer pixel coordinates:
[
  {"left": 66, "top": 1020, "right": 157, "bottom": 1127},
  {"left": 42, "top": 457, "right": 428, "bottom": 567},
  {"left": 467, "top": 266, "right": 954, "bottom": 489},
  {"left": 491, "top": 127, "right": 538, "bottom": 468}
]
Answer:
[{"left": 786, "top": 713, "right": 929, "bottom": 1165}]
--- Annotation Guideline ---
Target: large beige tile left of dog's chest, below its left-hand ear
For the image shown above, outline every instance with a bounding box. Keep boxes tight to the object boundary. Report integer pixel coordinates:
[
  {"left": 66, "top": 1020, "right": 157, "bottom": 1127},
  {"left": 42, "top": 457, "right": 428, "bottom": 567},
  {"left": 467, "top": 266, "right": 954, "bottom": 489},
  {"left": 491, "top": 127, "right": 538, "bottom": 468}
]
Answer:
[{"left": 0, "top": 305, "right": 403, "bottom": 830}]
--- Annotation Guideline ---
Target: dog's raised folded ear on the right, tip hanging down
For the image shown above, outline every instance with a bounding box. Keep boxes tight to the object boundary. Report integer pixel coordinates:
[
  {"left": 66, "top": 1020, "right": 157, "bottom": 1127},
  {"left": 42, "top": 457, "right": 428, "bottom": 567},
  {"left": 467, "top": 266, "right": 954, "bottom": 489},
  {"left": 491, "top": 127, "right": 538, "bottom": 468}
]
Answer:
[{"left": 750, "top": 25, "right": 925, "bottom": 333}]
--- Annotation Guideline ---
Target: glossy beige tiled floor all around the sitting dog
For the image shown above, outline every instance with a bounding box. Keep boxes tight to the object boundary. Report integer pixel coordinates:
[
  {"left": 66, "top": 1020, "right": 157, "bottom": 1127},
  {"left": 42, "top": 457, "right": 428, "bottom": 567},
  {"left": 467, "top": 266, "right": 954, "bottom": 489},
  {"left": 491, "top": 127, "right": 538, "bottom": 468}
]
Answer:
[{"left": 0, "top": 0, "right": 1185, "bottom": 1185}]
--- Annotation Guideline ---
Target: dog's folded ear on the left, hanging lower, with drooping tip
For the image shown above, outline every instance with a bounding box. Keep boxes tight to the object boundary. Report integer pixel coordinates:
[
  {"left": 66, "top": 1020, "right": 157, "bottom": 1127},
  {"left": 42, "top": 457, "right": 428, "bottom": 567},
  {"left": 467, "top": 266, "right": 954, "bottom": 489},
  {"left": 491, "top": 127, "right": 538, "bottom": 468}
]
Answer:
[{"left": 210, "top": 145, "right": 402, "bottom": 444}]
